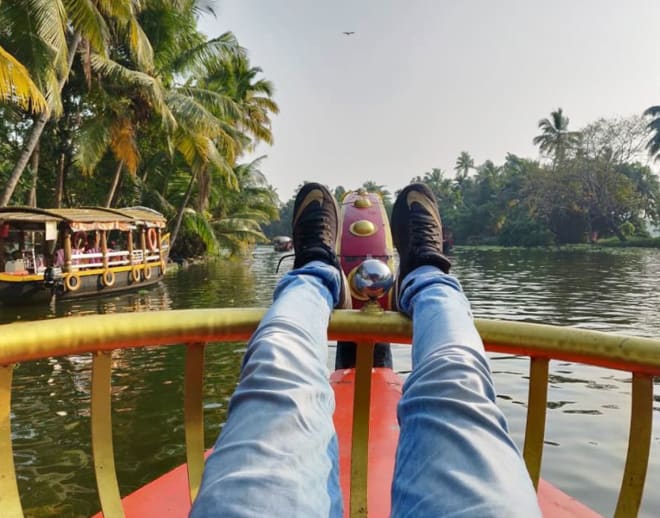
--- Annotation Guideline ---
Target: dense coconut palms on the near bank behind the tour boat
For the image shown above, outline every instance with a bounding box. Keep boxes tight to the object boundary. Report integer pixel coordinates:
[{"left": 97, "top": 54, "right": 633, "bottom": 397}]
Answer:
[{"left": 0, "top": 0, "right": 279, "bottom": 255}]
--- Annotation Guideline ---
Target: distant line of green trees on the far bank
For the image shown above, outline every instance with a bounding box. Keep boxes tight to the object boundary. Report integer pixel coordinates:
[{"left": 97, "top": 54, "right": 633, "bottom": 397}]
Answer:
[{"left": 266, "top": 106, "right": 660, "bottom": 246}]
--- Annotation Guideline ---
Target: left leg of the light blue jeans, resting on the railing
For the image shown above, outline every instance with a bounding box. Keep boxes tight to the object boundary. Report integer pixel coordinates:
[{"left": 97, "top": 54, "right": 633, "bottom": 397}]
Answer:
[{"left": 191, "top": 261, "right": 342, "bottom": 518}]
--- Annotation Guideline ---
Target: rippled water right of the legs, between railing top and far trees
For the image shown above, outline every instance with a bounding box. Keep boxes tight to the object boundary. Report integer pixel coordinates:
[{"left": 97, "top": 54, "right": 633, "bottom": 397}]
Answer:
[{"left": 454, "top": 249, "right": 660, "bottom": 336}]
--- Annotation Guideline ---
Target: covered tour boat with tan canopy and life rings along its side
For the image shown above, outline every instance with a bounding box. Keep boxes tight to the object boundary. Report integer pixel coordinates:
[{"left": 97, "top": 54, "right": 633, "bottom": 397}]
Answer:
[{"left": 0, "top": 207, "right": 169, "bottom": 304}]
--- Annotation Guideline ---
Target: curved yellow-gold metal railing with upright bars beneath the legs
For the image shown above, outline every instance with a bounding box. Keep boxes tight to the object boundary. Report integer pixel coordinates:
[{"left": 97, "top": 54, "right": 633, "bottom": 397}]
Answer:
[{"left": 0, "top": 309, "right": 660, "bottom": 518}]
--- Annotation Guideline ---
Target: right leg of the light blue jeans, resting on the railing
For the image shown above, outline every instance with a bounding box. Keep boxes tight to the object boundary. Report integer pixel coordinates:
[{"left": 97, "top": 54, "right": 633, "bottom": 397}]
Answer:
[{"left": 392, "top": 266, "right": 540, "bottom": 518}]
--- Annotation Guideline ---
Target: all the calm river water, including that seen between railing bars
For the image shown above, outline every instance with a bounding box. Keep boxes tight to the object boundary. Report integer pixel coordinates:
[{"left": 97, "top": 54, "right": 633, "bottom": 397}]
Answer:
[{"left": 5, "top": 247, "right": 660, "bottom": 517}]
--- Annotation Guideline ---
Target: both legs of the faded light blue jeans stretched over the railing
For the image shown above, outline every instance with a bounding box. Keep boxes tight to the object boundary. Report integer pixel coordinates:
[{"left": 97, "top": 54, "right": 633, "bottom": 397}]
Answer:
[{"left": 191, "top": 262, "right": 540, "bottom": 518}]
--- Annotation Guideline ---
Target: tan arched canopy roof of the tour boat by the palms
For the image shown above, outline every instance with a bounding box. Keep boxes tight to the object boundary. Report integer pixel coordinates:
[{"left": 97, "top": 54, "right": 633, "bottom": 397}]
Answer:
[{"left": 0, "top": 207, "right": 166, "bottom": 232}]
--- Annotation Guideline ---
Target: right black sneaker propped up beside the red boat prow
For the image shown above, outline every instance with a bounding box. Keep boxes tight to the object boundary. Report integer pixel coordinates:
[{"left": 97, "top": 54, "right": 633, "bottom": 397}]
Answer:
[{"left": 391, "top": 183, "right": 451, "bottom": 306}]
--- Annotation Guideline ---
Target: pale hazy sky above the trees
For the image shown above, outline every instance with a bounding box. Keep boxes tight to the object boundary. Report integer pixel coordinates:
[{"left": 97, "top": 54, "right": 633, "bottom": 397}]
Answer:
[{"left": 201, "top": 0, "right": 660, "bottom": 201}]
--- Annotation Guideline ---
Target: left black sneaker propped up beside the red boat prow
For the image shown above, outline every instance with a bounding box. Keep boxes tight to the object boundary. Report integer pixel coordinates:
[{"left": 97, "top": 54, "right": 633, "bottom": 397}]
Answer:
[{"left": 291, "top": 183, "right": 351, "bottom": 308}]
